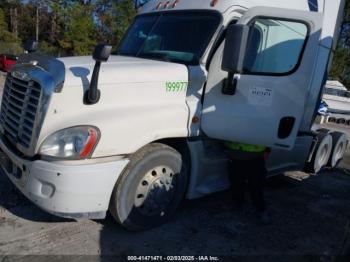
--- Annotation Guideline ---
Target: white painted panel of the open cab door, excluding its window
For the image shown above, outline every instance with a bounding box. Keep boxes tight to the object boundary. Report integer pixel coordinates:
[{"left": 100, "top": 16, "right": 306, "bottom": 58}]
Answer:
[{"left": 202, "top": 7, "right": 323, "bottom": 149}]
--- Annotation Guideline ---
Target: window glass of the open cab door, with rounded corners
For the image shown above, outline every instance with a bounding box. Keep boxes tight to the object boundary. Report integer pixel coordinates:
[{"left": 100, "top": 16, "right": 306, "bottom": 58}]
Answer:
[{"left": 244, "top": 18, "right": 308, "bottom": 75}]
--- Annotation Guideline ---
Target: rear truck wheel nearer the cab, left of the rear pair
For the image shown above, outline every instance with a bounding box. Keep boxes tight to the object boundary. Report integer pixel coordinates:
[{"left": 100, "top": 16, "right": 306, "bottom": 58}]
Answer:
[{"left": 305, "top": 132, "right": 333, "bottom": 174}]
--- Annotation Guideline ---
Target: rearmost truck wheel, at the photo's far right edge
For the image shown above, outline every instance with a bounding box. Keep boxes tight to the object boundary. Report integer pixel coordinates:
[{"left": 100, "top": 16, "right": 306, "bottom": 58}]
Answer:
[{"left": 328, "top": 132, "right": 348, "bottom": 168}]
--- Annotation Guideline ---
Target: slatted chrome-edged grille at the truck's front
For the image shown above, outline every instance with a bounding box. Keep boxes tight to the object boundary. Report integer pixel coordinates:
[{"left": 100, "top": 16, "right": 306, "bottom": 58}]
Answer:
[{"left": 0, "top": 74, "right": 41, "bottom": 149}]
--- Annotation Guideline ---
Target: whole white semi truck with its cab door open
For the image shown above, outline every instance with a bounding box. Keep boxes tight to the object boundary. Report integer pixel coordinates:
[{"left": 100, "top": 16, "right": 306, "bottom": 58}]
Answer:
[{"left": 0, "top": 0, "right": 347, "bottom": 230}]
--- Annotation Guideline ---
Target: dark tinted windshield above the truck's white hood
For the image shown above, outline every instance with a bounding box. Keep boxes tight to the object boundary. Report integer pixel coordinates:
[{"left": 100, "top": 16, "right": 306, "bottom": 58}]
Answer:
[{"left": 118, "top": 12, "right": 221, "bottom": 65}]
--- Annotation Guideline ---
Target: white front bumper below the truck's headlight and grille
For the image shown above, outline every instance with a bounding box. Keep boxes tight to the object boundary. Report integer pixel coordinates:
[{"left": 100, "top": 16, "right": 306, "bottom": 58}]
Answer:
[{"left": 0, "top": 140, "right": 129, "bottom": 219}]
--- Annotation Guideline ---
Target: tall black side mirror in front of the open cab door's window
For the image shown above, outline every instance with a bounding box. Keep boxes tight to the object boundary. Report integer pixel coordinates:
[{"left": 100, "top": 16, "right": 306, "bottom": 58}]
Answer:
[{"left": 221, "top": 24, "right": 251, "bottom": 95}]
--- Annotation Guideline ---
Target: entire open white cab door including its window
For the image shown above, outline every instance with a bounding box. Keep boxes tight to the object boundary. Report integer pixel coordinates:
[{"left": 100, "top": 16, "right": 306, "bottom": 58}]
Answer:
[{"left": 201, "top": 7, "right": 323, "bottom": 149}]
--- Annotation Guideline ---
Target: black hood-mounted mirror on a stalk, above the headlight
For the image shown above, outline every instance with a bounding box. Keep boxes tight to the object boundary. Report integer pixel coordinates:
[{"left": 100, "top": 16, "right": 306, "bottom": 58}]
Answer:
[{"left": 84, "top": 44, "right": 112, "bottom": 105}]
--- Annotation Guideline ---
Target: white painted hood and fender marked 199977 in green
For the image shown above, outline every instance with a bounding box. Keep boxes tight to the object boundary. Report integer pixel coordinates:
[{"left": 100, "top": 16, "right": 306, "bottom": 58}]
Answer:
[{"left": 37, "top": 56, "right": 191, "bottom": 157}]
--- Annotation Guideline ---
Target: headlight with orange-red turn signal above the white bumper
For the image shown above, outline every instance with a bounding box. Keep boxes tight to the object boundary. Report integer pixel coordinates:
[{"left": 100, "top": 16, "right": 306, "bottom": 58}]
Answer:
[{"left": 40, "top": 126, "right": 100, "bottom": 159}]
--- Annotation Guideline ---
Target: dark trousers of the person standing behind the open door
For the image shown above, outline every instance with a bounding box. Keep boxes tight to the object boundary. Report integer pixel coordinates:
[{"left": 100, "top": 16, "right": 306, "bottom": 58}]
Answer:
[{"left": 229, "top": 156, "right": 266, "bottom": 212}]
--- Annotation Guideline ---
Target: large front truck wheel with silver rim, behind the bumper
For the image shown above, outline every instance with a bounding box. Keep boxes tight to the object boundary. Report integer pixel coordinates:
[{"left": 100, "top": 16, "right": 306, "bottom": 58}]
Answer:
[{"left": 110, "top": 143, "right": 187, "bottom": 231}]
